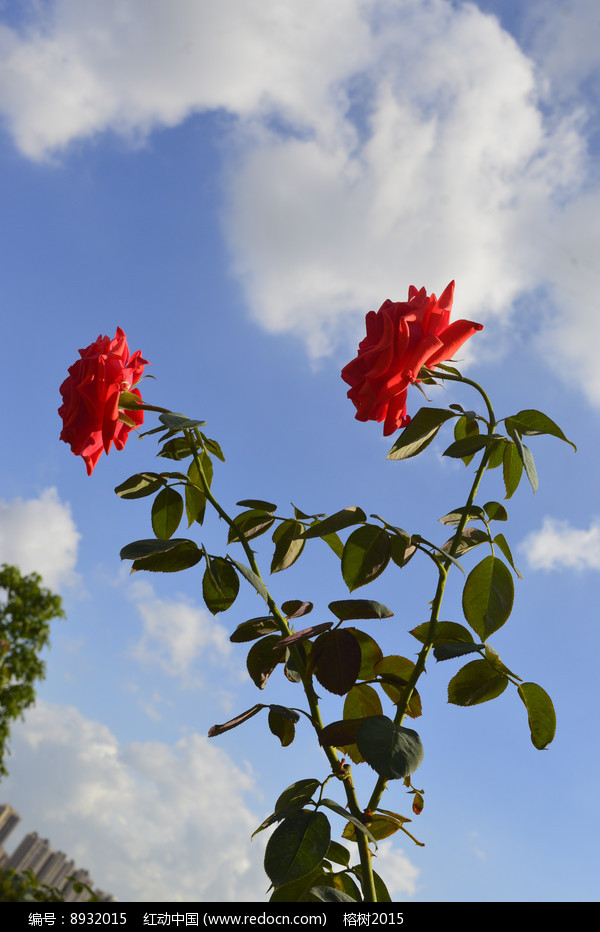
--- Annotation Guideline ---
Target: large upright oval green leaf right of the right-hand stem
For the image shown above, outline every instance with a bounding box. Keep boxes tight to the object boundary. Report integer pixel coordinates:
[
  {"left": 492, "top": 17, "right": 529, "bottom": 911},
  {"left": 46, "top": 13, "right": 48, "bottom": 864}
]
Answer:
[{"left": 462, "top": 556, "right": 515, "bottom": 641}]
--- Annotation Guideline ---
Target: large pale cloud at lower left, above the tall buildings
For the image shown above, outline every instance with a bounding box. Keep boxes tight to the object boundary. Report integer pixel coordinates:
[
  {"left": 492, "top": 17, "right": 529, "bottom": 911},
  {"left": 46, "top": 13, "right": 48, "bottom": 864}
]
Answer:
[{"left": 3, "top": 702, "right": 268, "bottom": 902}]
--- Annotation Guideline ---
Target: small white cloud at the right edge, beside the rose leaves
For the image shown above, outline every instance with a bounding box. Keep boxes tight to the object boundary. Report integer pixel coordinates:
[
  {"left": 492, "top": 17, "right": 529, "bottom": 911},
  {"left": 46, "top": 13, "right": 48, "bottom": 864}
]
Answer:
[{"left": 520, "top": 518, "right": 600, "bottom": 570}]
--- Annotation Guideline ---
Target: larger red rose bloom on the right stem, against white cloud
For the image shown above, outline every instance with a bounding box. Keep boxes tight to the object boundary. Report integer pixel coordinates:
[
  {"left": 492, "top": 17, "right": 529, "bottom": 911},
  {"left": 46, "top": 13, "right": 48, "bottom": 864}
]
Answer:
[{"left": 342, "top": 282, "right": 483, "bottom": 436}]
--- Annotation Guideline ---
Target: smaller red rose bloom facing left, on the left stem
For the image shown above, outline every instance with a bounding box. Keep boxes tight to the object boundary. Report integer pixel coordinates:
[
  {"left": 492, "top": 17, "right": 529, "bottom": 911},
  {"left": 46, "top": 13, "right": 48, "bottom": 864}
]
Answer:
[{"left": 58, "top": 327, "right": 148, "bottom": 476}]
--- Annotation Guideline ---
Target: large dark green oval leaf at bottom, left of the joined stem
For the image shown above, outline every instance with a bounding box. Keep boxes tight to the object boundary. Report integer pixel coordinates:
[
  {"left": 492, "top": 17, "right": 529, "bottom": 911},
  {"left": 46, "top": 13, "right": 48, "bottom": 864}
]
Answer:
[{"left": 264, "top": 810, "right": 331, "bottom": 886}]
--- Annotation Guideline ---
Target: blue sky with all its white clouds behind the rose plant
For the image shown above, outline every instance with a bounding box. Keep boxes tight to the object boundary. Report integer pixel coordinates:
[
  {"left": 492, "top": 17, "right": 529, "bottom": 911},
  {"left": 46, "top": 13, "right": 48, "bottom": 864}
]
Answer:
[{"left": 0, "top": 0, "right": 600, "bottom": 902}]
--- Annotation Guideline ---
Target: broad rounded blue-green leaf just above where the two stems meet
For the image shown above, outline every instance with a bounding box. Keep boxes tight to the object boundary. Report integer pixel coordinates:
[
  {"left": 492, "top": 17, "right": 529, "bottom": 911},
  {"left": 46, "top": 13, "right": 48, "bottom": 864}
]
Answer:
[{"left": 356, "top": 715, "right": 423, "bottom": 780}]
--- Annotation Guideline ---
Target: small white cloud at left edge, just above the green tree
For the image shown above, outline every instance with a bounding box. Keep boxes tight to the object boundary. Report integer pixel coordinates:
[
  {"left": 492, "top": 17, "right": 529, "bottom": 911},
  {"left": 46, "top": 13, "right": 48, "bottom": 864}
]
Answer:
[{"left": 0, "top": 488, "right": 80, "bottom": 589}]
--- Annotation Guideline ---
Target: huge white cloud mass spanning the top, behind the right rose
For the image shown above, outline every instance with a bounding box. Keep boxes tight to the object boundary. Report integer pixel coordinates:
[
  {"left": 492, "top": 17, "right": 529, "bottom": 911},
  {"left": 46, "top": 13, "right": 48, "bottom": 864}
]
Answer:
[{"left": 0, "top": 0, "right": 600, "bottom": 394}]
